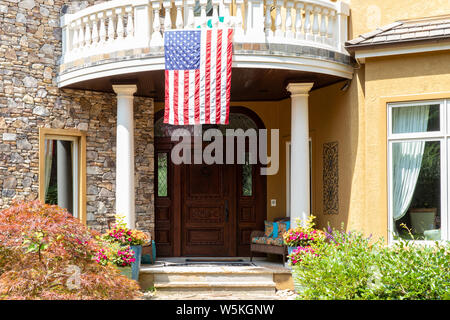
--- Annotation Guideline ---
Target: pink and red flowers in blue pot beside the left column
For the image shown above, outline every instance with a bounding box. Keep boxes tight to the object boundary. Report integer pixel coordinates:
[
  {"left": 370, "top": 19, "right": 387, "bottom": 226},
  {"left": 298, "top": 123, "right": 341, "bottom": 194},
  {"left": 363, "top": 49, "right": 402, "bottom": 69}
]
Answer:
[{"left": 102, "top": 215, "right": 150, "bottom": 281}]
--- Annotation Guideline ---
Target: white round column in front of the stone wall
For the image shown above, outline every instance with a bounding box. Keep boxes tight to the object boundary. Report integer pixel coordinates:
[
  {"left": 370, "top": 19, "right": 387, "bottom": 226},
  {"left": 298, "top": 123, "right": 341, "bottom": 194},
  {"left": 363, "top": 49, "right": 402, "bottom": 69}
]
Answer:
[{"left": 113, "top": 84, "right": 137, "bottom": 228}]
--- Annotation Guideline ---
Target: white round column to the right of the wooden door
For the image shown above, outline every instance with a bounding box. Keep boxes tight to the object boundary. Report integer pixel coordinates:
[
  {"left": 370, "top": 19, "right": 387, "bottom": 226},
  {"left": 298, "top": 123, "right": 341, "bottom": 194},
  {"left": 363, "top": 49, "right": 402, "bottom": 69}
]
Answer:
[{"left": 287, "top": 83, "right": 313, "bottom": 227}]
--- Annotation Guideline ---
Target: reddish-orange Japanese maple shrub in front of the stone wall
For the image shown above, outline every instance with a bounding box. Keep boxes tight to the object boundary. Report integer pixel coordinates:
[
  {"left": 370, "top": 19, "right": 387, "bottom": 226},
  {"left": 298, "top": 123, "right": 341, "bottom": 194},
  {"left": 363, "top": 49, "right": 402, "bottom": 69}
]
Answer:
[{"left": 0, "top": 201, "right": 140, "bottom": 300}]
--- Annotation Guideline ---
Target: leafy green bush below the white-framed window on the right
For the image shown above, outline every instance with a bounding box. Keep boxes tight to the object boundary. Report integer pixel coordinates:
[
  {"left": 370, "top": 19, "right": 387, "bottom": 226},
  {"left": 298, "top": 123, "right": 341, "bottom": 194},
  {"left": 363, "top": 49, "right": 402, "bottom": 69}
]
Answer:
[{"left": 293, "top": 225, "right": 450, "bottom": 299}]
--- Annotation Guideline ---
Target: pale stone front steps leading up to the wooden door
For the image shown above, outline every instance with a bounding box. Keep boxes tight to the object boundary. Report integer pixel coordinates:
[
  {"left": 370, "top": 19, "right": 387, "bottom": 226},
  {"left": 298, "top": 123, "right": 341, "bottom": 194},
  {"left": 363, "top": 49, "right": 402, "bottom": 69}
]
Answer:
[{"left": 139, "top": 257, "right": 294, "bottom": 299}]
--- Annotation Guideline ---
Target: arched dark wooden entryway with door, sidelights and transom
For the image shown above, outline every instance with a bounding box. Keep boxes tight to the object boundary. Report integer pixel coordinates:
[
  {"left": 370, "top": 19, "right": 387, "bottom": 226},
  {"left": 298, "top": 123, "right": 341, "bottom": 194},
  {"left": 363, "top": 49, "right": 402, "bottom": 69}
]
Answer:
[{"left": 155, "top": 107, "right": 267, "bottom": 257}]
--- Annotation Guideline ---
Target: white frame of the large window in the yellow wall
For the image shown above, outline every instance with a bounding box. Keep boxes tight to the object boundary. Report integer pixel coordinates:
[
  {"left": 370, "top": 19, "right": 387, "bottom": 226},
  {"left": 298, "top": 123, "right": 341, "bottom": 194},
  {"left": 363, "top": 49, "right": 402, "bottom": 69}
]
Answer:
[{"left": 387, "top": 99, "right": 450, "bottom": 244}]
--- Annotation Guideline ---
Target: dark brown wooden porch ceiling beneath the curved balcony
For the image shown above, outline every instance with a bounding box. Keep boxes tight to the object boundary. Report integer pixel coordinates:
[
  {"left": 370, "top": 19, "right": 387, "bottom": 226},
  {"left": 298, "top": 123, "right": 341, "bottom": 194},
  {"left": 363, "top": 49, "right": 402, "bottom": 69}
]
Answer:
[{"left": 66, "top": 68, "right": 342, "bottom": 101}]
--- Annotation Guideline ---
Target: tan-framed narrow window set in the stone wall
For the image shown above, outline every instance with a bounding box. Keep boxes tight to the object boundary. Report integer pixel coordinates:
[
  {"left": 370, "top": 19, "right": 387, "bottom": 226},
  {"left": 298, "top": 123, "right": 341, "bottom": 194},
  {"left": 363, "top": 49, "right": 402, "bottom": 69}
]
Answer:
[{"left": 39, "top": 128, "right": 86, "bottom": 222}]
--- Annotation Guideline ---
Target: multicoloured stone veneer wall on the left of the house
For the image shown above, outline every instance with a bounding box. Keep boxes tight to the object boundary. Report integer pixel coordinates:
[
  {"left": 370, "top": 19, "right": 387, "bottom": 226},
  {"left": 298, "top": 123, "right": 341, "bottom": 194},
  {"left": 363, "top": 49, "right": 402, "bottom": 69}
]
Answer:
[{"left": 0, "top": 0, "right": 154, "bottom": 233}]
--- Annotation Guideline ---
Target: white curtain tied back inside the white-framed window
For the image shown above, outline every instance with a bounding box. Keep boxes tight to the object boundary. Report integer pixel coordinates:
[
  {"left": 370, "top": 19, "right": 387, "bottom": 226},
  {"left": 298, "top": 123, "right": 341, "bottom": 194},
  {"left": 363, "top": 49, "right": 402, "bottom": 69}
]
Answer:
[{"left": 392, "top": 106, "right": 430, "bottom": 221}]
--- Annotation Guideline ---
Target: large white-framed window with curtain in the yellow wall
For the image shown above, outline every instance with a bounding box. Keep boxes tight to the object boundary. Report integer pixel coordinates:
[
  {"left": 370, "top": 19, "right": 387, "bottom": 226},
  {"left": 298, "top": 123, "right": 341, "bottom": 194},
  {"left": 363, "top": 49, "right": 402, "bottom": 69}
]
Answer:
[{"left": 388, "top": 100, "right": 450, "bottom": 241}]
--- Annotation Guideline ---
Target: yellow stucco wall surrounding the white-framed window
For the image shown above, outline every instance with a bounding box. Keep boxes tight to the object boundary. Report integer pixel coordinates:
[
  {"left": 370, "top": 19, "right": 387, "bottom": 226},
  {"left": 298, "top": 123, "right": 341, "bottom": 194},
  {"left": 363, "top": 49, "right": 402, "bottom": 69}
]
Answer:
[{"left": 310, "top": 0, "right": 450, "bottom": 239}]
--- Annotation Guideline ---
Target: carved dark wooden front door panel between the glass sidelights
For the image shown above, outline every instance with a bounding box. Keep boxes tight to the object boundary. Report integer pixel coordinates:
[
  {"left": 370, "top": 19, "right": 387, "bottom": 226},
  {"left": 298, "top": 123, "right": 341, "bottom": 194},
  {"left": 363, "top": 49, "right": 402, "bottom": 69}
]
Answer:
[{"left": 181, "top": 160, "right": 236, "bottom": 256}]
